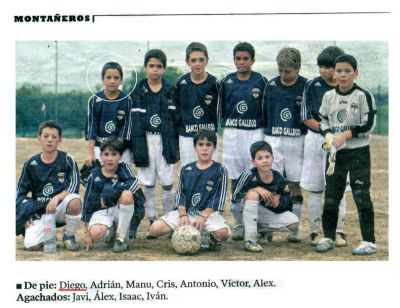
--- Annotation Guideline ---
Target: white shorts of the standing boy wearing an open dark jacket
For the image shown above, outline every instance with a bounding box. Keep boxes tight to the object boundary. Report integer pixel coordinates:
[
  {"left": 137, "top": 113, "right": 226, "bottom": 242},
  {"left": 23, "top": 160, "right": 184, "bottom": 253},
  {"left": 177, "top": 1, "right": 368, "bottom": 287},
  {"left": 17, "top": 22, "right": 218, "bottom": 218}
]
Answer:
[{"left": 137, "top": 134, "right": 174, "bottom": 186}]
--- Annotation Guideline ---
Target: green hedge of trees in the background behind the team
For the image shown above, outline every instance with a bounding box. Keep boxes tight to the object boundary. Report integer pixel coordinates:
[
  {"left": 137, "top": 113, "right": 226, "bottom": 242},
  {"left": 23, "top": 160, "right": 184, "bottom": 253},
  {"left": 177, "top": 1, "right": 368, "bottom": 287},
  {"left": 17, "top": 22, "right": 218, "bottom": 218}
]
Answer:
[{"left": 16, "top": 67, "right": 388, "bottom": 138}]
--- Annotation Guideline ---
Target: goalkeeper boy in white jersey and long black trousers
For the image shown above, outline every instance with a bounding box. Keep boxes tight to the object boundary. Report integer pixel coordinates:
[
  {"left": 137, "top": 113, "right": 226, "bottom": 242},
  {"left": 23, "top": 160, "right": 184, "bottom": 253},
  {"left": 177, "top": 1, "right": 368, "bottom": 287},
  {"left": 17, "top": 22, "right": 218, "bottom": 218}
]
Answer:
[{"left": 315, "top": 54, "right": 376, "bottom": 255}]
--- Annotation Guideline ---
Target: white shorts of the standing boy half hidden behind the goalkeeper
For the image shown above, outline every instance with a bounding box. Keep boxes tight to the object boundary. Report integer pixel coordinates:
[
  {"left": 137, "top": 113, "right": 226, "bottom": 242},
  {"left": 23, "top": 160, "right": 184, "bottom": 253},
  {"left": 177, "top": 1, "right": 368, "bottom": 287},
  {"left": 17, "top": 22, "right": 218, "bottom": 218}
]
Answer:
[{"left": 300, "top": 131, "right": 327, "bottom": 192}]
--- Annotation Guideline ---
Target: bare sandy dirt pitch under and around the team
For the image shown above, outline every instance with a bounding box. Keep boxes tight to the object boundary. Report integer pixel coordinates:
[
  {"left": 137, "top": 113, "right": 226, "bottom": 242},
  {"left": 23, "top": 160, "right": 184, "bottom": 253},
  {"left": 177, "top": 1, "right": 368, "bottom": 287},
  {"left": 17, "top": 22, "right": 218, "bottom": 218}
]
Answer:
[{"left": 16, "top": 136, "right": 389, "bottom": 261}]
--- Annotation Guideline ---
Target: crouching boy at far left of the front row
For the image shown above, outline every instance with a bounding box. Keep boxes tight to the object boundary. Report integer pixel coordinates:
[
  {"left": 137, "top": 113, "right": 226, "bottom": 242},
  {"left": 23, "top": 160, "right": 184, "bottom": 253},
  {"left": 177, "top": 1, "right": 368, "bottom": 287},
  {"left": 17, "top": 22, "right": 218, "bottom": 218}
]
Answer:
[{"left": 16, "top": 121, "right": 82, "bottom": 250}]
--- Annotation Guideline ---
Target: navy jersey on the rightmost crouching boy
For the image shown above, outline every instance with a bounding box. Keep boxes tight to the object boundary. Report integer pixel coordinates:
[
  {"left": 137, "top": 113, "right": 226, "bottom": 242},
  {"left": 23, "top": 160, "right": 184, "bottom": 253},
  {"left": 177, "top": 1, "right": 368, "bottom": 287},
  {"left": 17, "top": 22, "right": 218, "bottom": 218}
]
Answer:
[{"left": 232, "top": 167, "right": 293, "bottom": 213}]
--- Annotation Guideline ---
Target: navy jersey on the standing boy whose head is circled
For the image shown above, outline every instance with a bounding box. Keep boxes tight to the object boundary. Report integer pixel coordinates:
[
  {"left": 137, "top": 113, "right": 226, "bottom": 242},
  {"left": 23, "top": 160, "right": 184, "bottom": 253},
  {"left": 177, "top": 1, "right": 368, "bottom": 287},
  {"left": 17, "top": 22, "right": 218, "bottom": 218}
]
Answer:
[{"left": 85, "top": 91, "right": 132, "bottom": 146}]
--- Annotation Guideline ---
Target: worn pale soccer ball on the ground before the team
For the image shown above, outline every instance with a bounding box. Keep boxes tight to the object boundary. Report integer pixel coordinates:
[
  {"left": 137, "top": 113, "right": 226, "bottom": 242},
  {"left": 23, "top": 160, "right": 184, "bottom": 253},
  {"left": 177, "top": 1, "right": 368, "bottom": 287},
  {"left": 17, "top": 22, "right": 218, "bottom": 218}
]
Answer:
[{"left": 171, "top": 225, "right": 201, "bottom": 255}]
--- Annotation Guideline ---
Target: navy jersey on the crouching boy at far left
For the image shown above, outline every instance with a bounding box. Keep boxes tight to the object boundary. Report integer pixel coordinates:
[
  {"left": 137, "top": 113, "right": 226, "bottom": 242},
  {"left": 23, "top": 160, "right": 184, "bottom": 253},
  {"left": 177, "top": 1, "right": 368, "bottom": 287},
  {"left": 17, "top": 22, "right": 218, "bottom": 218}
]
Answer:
[{"left": 17, "top": 151, "right": 79, "bottom": 206}]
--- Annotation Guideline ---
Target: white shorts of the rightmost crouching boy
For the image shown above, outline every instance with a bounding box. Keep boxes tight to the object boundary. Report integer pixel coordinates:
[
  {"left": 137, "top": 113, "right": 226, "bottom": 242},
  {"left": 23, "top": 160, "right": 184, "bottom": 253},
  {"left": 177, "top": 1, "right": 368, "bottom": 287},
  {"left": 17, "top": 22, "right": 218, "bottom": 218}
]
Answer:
[{"left": 257, "top": 206, "right": 299, "bottom": 231}]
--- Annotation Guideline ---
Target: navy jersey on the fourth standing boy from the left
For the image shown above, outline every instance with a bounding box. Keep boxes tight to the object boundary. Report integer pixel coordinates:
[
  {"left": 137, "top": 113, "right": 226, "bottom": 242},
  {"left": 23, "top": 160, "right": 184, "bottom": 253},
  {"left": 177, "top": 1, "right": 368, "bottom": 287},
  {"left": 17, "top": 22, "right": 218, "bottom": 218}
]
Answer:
[{"left": 218, "top": 72, "right": 267, "bottom": 130}]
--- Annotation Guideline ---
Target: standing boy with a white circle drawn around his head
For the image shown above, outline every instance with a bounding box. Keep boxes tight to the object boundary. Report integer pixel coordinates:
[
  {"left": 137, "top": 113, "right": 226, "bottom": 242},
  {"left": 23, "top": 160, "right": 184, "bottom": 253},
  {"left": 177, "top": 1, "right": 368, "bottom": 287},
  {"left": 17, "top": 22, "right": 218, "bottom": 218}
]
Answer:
[{"left": 85, "top": 62, "right": 132, "bottom": 167}]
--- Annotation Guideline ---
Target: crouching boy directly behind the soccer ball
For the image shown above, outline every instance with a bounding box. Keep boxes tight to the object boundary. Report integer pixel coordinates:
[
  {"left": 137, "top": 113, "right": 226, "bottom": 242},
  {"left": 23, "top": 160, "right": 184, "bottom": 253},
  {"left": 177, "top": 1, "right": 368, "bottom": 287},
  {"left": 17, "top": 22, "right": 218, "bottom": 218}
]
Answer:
[{"left": 150, "top": 130, "right": 230, "bottom": 250}]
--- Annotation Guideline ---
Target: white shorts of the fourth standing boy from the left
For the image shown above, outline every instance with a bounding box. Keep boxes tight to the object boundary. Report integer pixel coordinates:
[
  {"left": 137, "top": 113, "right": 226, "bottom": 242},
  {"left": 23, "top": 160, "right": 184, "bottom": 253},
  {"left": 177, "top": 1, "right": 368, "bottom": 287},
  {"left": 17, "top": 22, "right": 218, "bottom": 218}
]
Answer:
[{"left": 222, "top": 128, "right": 263, "bottom": 180}]
